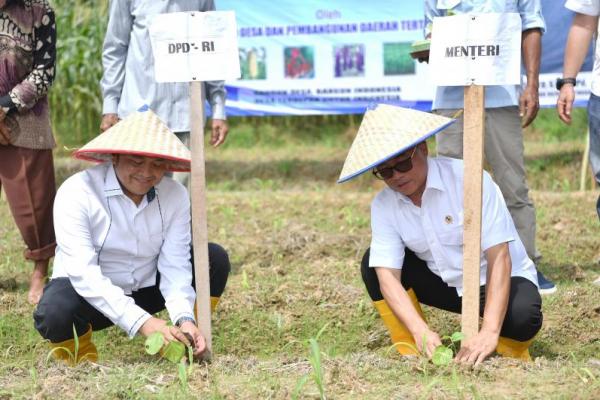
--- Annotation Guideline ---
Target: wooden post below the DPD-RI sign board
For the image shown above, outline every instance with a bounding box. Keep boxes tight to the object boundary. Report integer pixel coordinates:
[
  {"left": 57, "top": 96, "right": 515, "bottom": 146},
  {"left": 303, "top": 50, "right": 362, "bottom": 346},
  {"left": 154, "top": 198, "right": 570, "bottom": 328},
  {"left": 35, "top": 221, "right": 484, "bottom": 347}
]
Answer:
[{"left": 190, "top": 82, "right": 212, "bottom": 359}]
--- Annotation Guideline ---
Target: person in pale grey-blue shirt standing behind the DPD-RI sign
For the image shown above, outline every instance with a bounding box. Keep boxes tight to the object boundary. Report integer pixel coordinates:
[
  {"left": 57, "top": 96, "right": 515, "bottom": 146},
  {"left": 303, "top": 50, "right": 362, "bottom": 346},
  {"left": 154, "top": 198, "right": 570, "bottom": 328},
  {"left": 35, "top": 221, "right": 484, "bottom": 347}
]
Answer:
[{"left": 100, "top": 0, "right": 229, "bottom": 185}]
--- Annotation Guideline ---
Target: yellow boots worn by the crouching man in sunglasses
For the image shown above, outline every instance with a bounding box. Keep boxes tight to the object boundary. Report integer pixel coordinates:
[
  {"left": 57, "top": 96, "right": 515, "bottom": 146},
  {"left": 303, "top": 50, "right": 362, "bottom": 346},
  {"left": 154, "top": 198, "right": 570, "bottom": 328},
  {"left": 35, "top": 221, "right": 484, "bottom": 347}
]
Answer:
[{"left": 373, "top": 289, "right": 533, "bottom": 361}]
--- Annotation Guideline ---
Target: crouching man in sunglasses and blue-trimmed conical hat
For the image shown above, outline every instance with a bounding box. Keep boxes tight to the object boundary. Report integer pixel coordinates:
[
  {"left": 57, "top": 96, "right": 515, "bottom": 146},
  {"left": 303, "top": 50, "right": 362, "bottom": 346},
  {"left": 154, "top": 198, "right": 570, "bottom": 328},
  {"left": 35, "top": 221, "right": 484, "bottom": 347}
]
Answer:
[{"left": 339, "top": 105, "right": 542, "bottom": 364}]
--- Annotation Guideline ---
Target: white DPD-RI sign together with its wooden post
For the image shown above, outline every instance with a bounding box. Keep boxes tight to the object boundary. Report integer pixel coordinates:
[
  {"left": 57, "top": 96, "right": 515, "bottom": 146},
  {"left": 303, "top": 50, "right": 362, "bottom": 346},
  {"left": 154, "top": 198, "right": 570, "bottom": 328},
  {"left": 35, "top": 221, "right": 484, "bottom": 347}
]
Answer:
[{"left": 149, "top": 11, "right": 240, "bottom": 359}]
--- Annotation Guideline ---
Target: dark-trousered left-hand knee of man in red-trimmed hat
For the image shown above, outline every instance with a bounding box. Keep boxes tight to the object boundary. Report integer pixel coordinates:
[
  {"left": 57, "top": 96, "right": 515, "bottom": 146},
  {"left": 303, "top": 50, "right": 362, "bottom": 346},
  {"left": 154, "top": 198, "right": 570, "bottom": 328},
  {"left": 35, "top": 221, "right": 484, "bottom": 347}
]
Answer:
[{"left": 33, "top": 278, "right": 83, "bottom": 342}]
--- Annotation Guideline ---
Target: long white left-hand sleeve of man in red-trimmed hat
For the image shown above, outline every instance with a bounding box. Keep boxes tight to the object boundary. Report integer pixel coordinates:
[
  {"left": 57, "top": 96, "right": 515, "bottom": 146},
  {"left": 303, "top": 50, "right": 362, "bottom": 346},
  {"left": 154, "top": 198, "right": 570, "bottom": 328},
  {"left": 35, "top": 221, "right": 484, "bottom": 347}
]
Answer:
[{"left": 54, "top": 177, "right": 151, "bottom": 337}]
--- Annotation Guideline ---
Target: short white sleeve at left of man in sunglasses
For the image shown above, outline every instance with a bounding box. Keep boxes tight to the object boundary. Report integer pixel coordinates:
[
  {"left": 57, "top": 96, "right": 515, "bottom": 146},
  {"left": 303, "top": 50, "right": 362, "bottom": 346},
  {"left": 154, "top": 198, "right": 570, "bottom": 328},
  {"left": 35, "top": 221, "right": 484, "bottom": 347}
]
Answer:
[{"left": 369, "top": 192, "right": 404, "bottom": 269}]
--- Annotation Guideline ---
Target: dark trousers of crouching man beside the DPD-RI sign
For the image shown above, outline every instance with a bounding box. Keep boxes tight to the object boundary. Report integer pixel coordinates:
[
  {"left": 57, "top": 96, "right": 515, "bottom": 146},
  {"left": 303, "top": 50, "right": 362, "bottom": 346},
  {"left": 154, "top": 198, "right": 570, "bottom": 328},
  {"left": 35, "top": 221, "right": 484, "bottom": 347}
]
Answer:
[{"left": 33, "top": 243, "right": 231, "bottom": 343}]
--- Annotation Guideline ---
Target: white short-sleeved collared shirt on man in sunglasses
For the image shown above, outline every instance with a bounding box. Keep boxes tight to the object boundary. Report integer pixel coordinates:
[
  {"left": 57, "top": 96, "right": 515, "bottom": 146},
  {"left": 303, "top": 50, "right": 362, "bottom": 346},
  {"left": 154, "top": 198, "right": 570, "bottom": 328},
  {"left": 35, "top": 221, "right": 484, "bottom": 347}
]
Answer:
[{"left": 369, "top": 157, "right": 537, "bottom": 296}]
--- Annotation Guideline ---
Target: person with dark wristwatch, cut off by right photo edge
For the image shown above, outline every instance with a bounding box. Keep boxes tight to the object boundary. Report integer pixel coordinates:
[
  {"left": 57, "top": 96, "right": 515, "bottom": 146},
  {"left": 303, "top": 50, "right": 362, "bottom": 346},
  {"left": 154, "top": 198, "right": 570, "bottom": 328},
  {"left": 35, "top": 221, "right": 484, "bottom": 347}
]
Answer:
[{"left": 556, "top": 0, "right": 600, "bottom": 218}]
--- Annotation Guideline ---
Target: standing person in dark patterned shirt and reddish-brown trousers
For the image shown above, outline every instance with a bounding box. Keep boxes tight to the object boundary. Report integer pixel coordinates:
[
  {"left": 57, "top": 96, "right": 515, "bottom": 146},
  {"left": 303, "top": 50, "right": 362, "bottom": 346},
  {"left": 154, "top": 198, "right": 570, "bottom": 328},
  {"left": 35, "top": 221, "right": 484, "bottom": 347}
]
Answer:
[{"left": 0, "top": 0, "right": 56, "bottom": 304}]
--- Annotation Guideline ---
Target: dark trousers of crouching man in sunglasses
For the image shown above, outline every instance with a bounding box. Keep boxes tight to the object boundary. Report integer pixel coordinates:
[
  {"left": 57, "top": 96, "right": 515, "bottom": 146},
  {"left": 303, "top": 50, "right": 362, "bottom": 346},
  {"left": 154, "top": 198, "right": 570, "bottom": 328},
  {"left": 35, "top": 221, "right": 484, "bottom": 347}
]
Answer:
[{"left": 360, "top": 249, "right": 543, "bottom": 342}]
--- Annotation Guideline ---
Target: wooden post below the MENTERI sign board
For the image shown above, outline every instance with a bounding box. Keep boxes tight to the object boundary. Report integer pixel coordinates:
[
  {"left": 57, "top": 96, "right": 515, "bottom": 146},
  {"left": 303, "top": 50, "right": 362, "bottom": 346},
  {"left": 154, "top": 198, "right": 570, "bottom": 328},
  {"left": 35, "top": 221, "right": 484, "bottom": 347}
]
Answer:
[{"left": 462, "top": 85, "right": 485, "bottom": 339}]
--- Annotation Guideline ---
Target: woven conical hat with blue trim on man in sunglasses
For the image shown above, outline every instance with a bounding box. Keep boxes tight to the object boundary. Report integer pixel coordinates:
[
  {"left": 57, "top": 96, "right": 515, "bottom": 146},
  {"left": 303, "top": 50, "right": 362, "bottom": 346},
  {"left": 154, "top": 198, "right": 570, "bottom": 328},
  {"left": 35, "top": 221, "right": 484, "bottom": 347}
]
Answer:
[{"left": 338, "top": 104, "right": 455, "bottom": 183}]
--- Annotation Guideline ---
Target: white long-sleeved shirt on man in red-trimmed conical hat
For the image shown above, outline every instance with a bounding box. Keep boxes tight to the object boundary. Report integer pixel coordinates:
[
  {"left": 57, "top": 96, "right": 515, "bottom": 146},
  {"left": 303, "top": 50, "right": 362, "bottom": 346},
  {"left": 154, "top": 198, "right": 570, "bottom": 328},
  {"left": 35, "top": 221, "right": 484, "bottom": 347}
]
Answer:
[{"left": 52, "top": 163, "right": 196, "bottom": 337}]
